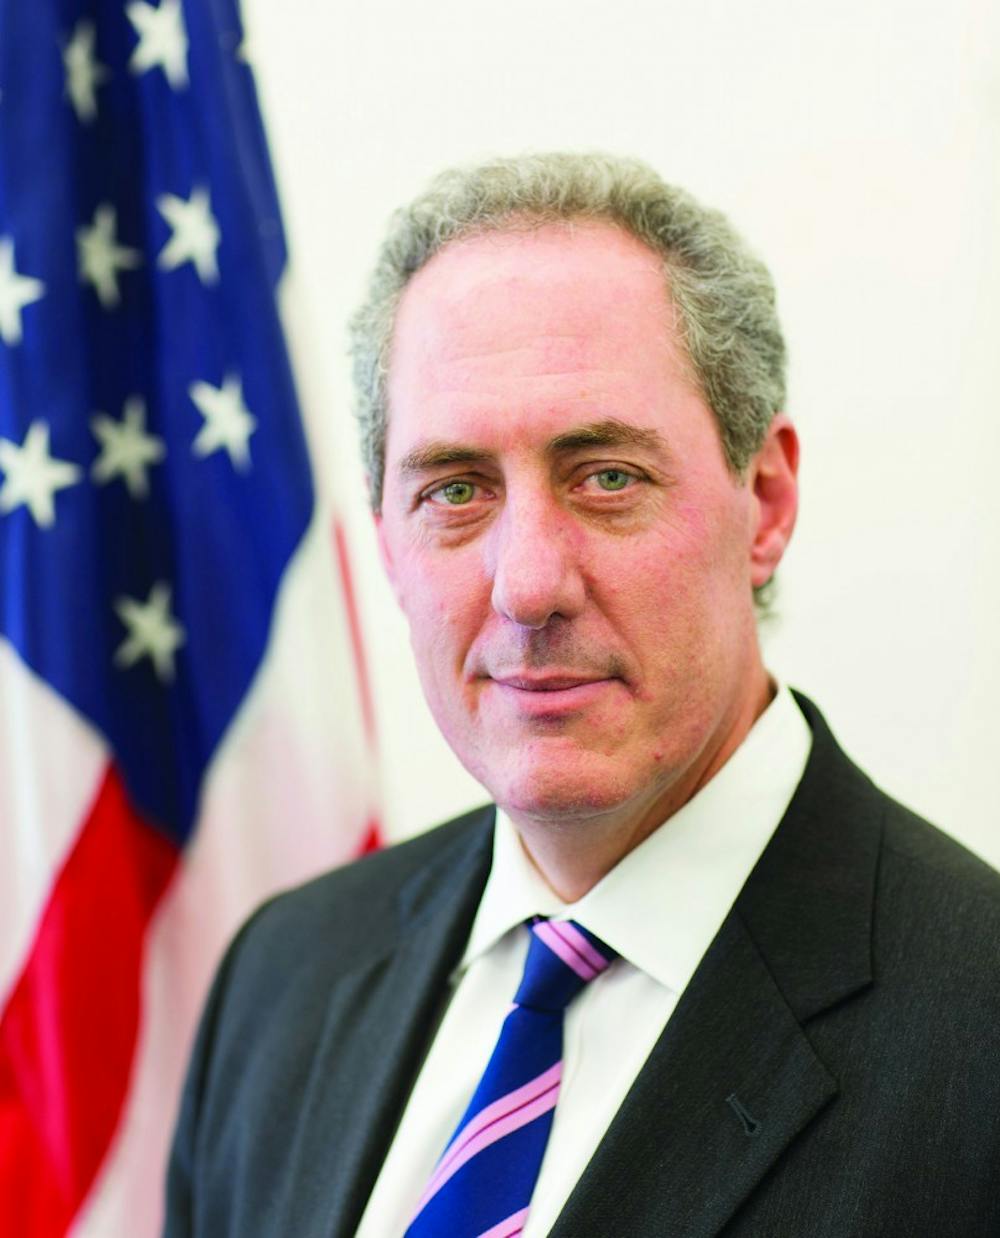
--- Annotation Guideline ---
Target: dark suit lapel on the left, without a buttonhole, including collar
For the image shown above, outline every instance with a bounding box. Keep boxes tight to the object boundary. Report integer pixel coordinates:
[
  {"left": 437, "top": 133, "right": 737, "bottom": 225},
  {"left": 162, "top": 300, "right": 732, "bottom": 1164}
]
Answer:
[{"left": 281, "top": 808, "right": 493, "bottom": 1238}]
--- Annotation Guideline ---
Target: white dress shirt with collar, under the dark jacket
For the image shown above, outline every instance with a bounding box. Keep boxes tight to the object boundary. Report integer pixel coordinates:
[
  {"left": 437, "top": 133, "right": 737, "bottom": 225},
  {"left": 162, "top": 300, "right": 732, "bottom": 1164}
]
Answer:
[{"left": 356, "top": 688, "right": 812, "bottom": 1238}]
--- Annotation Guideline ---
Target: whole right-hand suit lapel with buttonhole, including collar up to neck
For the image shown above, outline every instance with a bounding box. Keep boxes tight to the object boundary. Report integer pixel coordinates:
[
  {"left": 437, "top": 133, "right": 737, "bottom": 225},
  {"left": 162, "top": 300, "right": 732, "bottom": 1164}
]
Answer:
[{"left": 552, "top": 699, "right": 881, "bottom": 1238}]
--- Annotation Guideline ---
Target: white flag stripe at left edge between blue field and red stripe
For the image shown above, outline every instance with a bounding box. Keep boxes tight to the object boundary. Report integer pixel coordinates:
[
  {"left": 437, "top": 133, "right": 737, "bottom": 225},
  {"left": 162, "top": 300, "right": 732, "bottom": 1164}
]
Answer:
[{"left": 0, "top": 636, "right": 108, "bottom": 1009}]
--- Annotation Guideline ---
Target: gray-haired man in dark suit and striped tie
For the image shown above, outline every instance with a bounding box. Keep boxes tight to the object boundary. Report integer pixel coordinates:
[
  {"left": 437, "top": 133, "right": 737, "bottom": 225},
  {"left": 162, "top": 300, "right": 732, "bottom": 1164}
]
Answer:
[{"left": 167, "top": 156, "right": 1000, "bottom": 1238}]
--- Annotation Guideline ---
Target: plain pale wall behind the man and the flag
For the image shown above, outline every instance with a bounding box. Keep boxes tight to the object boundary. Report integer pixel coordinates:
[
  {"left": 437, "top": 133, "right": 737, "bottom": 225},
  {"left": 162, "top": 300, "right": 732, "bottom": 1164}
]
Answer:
[{"left": 238, "top": 0, "right": 1000, "bottom": 864}]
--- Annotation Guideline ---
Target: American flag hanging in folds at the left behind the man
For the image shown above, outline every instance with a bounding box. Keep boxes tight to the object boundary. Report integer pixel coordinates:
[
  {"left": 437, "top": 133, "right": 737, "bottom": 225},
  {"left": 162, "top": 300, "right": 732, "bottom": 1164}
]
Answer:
[{"left": 0, "top": 0, "right": 374, "bottom": 1238}]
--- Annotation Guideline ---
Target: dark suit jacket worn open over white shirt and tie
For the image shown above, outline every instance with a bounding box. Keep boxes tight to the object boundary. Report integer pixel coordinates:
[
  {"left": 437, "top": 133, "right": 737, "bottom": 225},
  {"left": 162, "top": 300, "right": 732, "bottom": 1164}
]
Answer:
[{"left": 166, "top": 701, "right": 1000, "bottom": 1238}]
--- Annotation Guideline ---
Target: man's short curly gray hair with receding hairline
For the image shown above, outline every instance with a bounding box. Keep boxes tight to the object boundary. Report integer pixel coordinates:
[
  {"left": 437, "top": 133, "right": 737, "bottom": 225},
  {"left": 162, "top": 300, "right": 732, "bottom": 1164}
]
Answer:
[{"left": 350, "top": 154, "right": 785, "bottom": 511}]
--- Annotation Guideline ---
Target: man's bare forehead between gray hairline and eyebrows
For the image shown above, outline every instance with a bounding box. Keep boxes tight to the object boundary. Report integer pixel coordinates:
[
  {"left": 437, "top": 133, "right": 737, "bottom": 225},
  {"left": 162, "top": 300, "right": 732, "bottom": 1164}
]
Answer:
[{"left": 389, "top": 224, "right": 688, "bottom": 420}]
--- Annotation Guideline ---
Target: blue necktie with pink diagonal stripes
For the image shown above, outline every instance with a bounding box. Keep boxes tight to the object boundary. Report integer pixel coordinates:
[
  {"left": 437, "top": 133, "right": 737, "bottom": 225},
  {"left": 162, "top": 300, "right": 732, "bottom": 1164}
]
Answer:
[{"left": 406, "top": 917, "right": 618, "bottom": 1238}]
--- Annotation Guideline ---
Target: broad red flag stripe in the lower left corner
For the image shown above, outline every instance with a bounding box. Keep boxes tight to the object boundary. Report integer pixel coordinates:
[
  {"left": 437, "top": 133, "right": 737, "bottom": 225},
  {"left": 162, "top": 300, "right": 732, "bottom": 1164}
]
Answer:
[{"left": 0, "top": 766, "right": 177, "bottom": 1238}]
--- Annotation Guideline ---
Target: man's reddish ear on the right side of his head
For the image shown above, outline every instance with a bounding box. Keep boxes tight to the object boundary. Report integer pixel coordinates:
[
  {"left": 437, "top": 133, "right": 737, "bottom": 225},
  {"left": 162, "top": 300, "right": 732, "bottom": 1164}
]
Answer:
[{"left": 746, "top": 412, "right": 798, "bottom": 589}]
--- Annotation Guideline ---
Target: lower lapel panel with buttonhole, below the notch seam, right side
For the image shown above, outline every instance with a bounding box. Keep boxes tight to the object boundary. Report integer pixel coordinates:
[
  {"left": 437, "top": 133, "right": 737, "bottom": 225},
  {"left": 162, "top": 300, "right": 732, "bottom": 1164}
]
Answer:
[{"left": 552, "top": 915, "right": 837, "bottom": 1238}]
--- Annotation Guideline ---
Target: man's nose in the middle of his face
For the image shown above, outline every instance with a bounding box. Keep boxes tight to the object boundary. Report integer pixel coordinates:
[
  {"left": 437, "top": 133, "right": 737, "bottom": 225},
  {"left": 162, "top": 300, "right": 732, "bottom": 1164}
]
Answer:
[{"left": 489, "top": 496, "right": 585, "bottom": 628}]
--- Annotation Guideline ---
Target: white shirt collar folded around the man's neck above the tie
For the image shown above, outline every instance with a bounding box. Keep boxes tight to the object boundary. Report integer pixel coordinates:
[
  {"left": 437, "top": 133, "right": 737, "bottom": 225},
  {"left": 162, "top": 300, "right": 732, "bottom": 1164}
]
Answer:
[{"left": 459, "top": 687, "right": 812, "bottom": 993}]
